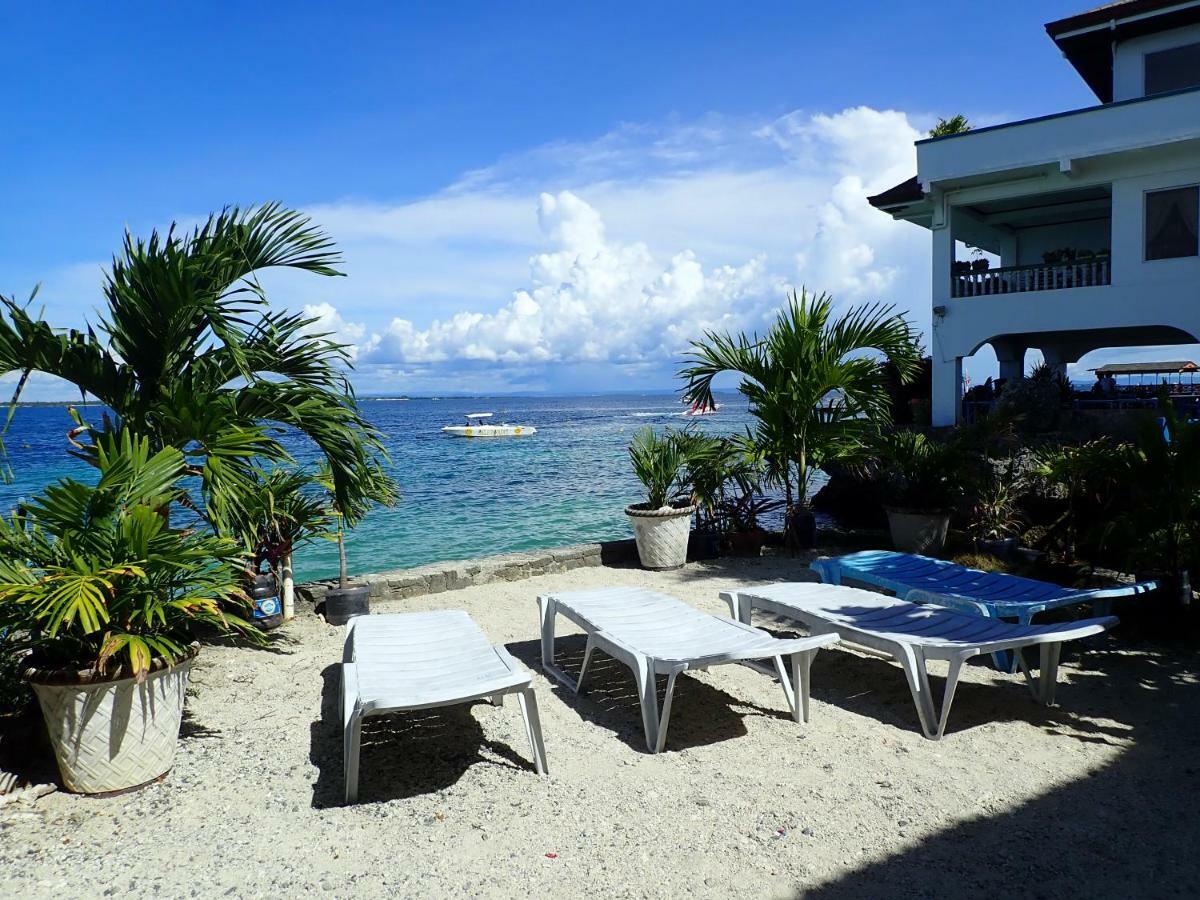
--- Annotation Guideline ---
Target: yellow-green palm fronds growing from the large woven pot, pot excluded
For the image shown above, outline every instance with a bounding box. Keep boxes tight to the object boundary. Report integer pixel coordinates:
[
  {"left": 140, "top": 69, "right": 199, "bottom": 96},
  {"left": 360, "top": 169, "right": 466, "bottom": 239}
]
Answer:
[{"left": 0, "top": 431, "right": 262, "bottom": 678}]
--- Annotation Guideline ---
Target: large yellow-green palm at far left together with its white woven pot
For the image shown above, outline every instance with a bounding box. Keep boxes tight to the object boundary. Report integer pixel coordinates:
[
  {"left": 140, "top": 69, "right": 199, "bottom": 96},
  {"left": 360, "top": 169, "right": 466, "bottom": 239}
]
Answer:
[{"left": 0, "top": 431, "right": 262, "bottom": 793}]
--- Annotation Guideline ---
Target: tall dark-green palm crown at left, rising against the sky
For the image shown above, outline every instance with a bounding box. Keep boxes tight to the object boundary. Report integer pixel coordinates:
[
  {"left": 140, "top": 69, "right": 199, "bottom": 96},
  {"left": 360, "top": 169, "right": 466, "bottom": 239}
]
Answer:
[{"left": 0, "top": 204, "right": 393, "bottom": 530}]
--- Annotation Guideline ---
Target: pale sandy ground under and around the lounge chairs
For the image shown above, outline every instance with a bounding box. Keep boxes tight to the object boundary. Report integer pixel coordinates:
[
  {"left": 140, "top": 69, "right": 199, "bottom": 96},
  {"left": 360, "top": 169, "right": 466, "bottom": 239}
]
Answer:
[{"left": 0, "top": 559, "right": 1200, "bottom": 898}]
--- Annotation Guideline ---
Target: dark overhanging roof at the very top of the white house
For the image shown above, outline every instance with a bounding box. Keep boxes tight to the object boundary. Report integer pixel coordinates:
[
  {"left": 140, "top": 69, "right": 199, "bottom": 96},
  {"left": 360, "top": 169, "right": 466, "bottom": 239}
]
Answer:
[{"left": 1046, "top": 0, "right": 1200, "bottom": 103}]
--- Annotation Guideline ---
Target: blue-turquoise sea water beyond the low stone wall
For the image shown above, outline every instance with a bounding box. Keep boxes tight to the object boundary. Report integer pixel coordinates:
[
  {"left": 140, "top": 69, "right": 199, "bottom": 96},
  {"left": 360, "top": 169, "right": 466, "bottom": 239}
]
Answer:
[{"left": 0, "top": 394, "right": 825, "bottom": 581}]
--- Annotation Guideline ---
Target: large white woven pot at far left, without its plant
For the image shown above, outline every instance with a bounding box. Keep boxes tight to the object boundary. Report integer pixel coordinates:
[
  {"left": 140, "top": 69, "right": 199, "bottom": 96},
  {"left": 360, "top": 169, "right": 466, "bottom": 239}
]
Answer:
[{"left": 26, "top": 653, "right": 196, "bottom": 793}]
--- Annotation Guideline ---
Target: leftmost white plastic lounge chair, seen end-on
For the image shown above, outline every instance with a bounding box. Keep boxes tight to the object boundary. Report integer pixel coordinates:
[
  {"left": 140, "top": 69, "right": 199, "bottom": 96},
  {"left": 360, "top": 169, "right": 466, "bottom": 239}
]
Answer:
[{"left": 341, "top": 610, "right": 546, "bottom": 803}]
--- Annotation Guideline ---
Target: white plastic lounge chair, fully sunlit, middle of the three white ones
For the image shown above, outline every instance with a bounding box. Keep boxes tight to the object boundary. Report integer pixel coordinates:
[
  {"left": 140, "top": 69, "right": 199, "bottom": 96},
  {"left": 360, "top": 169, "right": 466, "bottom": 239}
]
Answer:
[{"left": 538, "top": 588, "right": 838, "bottom": 754}]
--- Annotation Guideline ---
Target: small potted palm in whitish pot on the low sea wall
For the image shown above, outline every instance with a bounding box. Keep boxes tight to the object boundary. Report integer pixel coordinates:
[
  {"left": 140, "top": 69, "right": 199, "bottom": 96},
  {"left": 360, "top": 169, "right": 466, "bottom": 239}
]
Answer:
[{"left": 625, "top": 426, "right": 696, "bottom": 569}]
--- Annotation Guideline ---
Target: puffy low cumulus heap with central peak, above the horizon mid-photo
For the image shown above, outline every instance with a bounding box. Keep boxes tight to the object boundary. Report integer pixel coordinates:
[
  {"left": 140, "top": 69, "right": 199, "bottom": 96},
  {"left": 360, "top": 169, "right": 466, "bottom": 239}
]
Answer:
[{"left": 361, "top": 191, "right": 769, "bottom": 374}]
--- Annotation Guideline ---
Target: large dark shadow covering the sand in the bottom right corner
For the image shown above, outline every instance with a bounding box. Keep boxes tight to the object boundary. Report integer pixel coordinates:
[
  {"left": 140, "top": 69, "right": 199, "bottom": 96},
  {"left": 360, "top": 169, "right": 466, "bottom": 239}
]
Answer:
[{"left": 804, "top": 642, "right": 1200, "bottom": 899}]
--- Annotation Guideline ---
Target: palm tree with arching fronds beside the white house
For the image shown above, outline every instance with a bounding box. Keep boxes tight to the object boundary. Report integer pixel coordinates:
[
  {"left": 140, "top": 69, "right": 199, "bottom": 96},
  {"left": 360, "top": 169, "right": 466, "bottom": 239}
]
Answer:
[{"left": 679, "top": 288, "right": 922, "bottom": 546}]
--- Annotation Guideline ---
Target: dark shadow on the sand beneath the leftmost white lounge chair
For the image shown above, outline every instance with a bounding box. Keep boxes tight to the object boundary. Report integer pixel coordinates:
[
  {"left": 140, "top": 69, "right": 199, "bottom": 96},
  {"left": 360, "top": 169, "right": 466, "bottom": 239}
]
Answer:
[{"left": 310, "top": 665, "right": 535, "bottom": 809}]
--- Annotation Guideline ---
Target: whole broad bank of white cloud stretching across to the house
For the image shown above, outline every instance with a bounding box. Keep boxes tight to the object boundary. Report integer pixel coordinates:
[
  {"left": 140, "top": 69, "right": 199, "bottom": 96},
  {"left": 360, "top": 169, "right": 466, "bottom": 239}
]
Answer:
[{"left": 295, "top": 107, "right": 929, "bottom": 389}]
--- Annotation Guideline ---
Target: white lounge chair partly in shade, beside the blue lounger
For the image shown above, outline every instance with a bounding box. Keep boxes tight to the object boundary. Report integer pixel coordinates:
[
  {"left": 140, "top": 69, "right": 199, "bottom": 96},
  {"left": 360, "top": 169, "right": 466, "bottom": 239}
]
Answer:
[{"left": 721, "top": 582, "right": 1117, "bottom": 740}]
